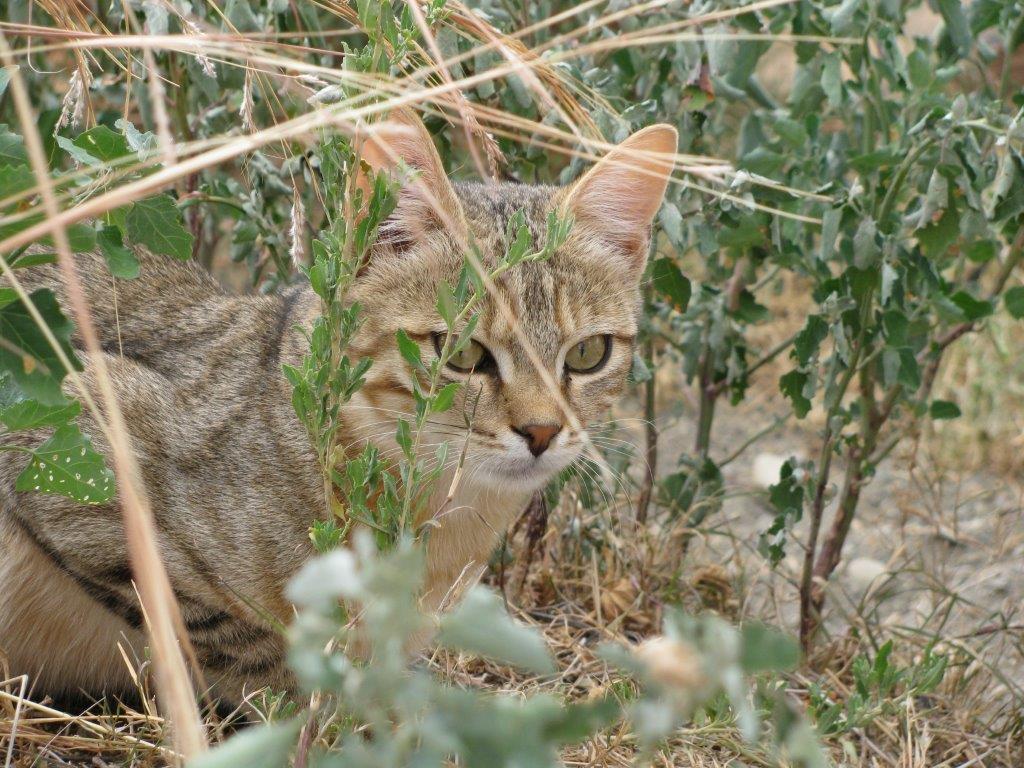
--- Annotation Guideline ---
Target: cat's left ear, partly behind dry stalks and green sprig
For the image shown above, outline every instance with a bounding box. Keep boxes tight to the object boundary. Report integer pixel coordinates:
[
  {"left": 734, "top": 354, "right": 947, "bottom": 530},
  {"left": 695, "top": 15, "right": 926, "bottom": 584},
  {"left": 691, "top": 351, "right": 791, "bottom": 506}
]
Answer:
[{"left": 356, "top": 110, "right": 465, "bottom": 248}]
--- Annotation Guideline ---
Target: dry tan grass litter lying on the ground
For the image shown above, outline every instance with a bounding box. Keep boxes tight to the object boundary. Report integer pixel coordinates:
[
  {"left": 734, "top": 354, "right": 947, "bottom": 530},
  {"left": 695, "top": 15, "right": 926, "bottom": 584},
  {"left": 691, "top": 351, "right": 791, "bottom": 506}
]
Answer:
[{"left": 0, "top": 479, "right": 1024, "bottom": 768}]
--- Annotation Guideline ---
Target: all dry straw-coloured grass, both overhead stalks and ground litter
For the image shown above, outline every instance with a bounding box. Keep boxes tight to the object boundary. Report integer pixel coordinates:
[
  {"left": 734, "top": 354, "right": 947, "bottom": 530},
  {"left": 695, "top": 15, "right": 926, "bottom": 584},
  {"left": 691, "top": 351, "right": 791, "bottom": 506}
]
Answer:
[{"left": 0, "top": 0, "right": 1024, "bottom": 768}]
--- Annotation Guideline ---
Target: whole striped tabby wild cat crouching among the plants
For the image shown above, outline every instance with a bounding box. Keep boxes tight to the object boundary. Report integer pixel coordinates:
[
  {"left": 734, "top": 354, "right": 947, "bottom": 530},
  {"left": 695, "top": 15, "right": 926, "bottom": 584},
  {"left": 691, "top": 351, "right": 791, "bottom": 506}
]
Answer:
[{"left": 0, "top": 116, "right": 677, "bottom": 698}]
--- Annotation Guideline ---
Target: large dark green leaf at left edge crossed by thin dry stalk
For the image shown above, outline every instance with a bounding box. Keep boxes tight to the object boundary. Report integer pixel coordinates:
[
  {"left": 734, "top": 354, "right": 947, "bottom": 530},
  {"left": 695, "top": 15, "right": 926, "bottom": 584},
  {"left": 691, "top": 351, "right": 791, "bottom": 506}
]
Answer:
[{"left": 0, "top": 289, "right": 82, "bottom": 406}]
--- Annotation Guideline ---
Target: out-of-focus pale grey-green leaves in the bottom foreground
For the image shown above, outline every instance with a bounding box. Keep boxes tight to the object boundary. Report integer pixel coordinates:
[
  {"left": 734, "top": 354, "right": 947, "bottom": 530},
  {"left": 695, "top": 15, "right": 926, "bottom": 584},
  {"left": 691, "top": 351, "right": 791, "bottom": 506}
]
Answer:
[{"left": 176, "top": 536, "right": 824, "bottom": 768}]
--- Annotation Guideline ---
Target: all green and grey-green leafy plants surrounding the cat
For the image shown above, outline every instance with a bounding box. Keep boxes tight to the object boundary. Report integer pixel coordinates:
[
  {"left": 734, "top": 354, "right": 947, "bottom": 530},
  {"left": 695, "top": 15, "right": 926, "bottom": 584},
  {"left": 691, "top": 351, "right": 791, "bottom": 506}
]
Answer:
[{"left": 0, "top": 0, "right": 1024, "bottom": 765}]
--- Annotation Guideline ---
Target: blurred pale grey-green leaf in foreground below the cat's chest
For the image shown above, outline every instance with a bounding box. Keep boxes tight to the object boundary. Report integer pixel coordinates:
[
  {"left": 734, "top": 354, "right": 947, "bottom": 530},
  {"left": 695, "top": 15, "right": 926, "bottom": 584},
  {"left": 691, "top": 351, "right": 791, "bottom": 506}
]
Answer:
[{"left": 438, "top": 587, "right": 555, "bottom": 675}]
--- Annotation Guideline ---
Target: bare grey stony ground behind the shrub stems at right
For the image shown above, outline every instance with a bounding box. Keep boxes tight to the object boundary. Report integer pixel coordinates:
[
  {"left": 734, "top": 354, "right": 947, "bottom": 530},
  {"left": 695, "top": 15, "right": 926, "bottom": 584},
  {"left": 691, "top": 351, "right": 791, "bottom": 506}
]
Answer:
[{"left": 658, "top": 398, "right": 1024, "bottom": 720}]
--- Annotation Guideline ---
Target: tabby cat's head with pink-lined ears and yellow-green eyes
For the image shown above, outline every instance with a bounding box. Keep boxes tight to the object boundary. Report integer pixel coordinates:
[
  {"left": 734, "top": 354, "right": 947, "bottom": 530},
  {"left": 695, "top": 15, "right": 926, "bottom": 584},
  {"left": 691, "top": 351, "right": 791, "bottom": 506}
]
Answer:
[{"left": 348, "top": 114, "right": 677, "bottom": 490}]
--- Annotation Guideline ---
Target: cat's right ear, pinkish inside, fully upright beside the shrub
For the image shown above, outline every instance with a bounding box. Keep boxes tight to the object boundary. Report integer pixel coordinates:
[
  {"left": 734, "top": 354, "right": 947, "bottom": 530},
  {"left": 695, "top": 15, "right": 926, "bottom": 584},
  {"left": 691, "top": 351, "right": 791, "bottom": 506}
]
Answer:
[{"left": 563, "top": 124, "right": 679, "bottom": 269}]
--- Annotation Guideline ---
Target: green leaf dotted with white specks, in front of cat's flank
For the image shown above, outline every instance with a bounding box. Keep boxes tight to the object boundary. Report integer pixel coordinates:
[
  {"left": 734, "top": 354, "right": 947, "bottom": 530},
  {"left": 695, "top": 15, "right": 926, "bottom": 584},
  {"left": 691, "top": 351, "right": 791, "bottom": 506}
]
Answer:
[{"left": 14, "top": 424, "right": 114, "bottom": 504}]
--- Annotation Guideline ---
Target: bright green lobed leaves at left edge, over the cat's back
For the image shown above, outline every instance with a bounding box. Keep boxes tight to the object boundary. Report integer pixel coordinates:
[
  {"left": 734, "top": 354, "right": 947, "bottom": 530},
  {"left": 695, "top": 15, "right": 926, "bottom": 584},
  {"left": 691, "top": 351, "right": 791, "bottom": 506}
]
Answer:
[{"left": 0, "top": 107, "right": 191, "bottom": 504}]
